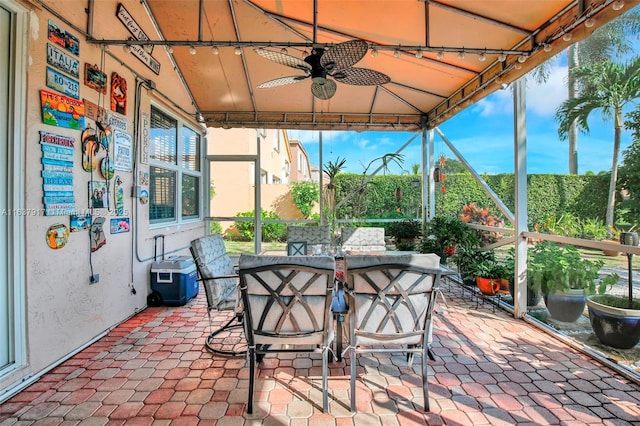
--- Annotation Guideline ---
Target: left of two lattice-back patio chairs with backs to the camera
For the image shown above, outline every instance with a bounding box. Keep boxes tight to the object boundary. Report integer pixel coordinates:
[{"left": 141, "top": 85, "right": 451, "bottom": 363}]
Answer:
[{"left": 238, "top": 254, "right": 335, "bottom": 414}]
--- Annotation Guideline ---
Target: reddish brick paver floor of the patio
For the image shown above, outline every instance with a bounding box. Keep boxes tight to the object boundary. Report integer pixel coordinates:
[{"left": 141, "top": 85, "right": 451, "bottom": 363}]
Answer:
[{"left": 0, "top": 284, "right": 640, "bottom": 426}]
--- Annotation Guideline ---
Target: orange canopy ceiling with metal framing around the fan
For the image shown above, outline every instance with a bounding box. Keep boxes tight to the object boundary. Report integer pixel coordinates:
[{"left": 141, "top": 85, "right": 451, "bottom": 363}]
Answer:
[{"left": 40, "top": 0, "right": 639, "bottom": 130}]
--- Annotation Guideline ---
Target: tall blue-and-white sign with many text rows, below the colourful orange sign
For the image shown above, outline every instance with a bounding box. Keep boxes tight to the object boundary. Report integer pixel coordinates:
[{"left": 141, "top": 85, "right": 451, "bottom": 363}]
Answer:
[{"left": 40, "top": 131, "right": 76, "bottom": 216}]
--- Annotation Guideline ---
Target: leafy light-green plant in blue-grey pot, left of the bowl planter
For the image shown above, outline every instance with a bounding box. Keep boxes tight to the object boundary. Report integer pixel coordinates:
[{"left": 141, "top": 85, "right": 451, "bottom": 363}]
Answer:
[{"left": 528, "top": 241, "right": 613, "bottom": 322}]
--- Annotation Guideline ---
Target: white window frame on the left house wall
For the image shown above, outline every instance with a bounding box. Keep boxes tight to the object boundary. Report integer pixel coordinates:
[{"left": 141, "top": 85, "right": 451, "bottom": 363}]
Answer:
[{"left": 149, "top": 102, "right": 205, "bottom": 228}]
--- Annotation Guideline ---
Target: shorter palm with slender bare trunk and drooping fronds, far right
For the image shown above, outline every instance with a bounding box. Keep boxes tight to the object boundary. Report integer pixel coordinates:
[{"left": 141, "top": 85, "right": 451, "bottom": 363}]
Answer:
[{"left": 555, "top": 57, "right": 640, "bottom": 233}]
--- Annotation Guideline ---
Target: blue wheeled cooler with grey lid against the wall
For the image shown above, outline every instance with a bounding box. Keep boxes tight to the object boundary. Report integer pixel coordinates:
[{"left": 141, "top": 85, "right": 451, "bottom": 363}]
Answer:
[{"left": 151, "top": 256, "right": 199, "bottom": 306}]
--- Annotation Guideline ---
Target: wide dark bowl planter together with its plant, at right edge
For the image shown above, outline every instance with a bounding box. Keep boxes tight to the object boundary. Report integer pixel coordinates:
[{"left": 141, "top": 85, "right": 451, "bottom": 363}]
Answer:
[{"left": 587, "top": 232, "right": 640, "bottom": 349}]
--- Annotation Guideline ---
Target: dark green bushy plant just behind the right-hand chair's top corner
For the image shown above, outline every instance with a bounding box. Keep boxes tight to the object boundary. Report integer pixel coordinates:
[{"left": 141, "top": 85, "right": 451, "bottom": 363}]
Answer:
[{"left": 420, "top": 216, "right": 478, "bottom": 264}]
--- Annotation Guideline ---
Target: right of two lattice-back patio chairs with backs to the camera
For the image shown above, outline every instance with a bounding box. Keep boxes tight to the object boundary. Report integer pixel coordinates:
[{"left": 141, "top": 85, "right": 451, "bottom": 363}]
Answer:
[{"left": 345, "top": 254, "right": 441, "bottom": 411}]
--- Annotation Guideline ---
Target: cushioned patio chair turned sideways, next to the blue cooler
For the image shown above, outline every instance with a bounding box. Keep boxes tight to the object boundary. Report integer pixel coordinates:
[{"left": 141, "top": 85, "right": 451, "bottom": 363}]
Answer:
[{"left": 189, "top": 234, "right": 246, "bottom": 356}]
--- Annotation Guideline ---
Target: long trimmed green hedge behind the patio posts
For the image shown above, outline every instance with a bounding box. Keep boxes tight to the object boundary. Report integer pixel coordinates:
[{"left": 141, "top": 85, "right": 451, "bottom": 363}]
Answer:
[{"left": 335, "top": 173, "right": 609, "bottom": 228}]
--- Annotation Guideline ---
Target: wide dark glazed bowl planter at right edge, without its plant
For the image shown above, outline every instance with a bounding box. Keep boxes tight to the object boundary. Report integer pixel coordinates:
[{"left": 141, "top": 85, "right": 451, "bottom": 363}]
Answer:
[{"left": 587, "top": 296, "right": 640, "bottom": 349}]
